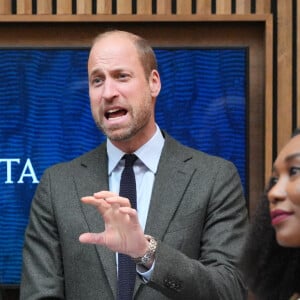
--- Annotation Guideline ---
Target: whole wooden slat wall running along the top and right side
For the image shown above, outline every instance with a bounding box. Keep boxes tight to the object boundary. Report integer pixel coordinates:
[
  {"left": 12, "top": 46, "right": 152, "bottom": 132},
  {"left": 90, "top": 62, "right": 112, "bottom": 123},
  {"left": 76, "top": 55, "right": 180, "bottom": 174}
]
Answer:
[{"left": 0, "top": 0, "right": 300, "bottom": 192}]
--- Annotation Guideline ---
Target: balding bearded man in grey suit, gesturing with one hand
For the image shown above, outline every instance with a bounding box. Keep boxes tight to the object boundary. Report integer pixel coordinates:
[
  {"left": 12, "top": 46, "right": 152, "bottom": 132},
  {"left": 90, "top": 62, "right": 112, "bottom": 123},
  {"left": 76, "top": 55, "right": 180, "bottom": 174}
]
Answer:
[{"left": 21, "top": 31, "right": 247, "bottom": 300}]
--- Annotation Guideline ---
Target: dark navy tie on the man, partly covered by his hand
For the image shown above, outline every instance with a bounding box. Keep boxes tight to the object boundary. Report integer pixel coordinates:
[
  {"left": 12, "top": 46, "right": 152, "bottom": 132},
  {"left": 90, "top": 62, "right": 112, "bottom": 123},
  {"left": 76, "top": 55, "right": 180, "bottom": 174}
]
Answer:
[{"left": 118, "top": 154, "right": 137, "bottom": 300}]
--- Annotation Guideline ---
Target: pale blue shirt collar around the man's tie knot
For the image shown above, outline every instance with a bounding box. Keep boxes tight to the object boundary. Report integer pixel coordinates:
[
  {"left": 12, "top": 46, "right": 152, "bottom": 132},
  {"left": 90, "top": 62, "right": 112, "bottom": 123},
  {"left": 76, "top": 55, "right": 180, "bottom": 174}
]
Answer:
[{"left": 107, "top": 125, "right": 165, "bottom": 175}]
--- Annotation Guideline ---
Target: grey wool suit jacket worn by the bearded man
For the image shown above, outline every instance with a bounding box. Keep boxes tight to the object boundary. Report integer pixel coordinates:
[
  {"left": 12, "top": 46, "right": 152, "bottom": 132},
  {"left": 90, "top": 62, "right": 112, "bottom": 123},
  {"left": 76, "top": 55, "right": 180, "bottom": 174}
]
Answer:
[{"left": 20, "top": 134, "right": 247, "bottom": 300}]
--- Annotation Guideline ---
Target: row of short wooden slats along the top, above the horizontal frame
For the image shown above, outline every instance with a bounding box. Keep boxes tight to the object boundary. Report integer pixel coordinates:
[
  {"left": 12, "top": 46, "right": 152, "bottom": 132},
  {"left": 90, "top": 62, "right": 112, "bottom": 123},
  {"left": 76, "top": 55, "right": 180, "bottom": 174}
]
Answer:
[{"left": 4, "top": 0, "right": 276, "bottom": 15}]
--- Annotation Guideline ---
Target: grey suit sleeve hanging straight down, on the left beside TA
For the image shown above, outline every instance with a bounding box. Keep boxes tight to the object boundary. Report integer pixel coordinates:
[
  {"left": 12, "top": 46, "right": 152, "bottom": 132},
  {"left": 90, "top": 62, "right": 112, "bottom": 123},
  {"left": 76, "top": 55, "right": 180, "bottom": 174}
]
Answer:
[{"left": 20, "top": 171, "right": 64, "bottom": 300}]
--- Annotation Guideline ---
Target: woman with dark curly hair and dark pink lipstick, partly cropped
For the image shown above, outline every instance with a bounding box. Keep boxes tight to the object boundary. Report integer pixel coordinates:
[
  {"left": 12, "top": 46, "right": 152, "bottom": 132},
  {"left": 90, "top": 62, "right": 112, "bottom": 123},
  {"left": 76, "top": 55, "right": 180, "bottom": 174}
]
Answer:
[{"left": 241, "top": 129, "right": 300, "bottom": 300}]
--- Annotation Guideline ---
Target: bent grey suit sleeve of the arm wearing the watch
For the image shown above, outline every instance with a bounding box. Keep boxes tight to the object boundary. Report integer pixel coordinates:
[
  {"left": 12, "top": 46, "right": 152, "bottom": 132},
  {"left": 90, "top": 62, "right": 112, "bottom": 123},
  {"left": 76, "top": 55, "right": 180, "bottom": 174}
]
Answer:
[{"left": 148, "top": 162, "right": 248, "bottom": 300}]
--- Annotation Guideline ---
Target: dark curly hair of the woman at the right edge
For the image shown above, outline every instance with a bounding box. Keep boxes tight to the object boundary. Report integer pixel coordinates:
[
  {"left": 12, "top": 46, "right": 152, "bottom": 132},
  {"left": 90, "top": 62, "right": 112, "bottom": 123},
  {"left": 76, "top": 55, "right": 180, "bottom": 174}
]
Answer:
[{"left": 240, "top": 193, "right": 300, "bottom": 300}]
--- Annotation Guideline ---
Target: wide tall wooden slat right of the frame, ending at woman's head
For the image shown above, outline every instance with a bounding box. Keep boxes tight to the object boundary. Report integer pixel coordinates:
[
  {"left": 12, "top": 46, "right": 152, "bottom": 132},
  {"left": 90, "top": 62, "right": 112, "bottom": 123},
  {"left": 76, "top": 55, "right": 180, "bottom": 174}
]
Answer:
[{"left": 277, "top": 0, "right": 293, "bottom": 151}]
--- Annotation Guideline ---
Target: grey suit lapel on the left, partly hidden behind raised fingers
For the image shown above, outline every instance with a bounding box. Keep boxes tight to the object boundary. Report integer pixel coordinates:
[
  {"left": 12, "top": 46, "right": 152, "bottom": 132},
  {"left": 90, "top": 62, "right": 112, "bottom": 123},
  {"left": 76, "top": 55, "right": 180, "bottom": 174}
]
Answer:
[{"left": 75, "top": 144, "right": 117, "bottom": 296}]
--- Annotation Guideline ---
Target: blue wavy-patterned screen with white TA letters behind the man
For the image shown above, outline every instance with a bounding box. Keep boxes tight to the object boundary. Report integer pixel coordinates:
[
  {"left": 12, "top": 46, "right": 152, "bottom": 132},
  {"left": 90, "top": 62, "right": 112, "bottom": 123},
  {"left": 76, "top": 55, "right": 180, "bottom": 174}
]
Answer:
[{"left": 0, "top": 48, "right": 247, "bottom": 284}]
